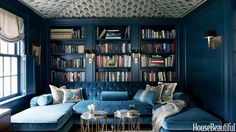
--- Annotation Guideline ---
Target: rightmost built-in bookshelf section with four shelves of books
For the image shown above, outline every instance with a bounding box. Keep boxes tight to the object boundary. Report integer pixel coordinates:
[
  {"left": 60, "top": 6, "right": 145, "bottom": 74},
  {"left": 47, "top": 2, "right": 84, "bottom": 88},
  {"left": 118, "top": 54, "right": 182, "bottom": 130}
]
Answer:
[{"left": 140, "top": 25, "right": 176, "bottom": 82}]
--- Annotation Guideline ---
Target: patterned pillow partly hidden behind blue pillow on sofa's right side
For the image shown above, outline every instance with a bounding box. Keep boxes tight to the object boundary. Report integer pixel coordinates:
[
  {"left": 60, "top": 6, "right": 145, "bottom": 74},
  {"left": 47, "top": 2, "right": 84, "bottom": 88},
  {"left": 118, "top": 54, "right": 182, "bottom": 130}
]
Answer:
[{"left": 145, "top": 84, "right": 165, "bottom": 103}]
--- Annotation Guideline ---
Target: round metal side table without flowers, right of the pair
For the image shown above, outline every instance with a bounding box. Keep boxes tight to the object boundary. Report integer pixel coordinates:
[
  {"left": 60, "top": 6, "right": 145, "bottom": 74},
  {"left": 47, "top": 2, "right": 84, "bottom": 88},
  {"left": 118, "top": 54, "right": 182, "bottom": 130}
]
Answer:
[{"left": 114, "top": 110, "right": 140, "bottom": 132}]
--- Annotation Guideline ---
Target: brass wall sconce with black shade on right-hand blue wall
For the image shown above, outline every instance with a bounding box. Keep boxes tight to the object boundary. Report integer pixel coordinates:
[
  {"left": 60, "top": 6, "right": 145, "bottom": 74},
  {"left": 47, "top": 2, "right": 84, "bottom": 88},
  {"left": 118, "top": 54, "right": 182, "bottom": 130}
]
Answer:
[{"left": 204, "top": 29, "right": 222, "bottom": 49}]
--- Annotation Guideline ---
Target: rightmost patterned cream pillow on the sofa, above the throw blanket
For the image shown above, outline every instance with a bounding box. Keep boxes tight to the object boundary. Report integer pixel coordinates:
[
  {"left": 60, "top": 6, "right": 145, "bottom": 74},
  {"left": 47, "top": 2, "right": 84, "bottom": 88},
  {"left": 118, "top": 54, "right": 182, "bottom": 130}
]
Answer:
[{"left": 158, "top": 82, "right": 177, "bottom": 103}]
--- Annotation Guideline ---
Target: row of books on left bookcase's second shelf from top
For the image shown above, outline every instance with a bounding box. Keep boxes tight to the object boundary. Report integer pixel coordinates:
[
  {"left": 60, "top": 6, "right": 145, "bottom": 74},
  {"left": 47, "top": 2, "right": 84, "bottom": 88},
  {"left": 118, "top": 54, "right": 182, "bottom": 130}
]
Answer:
[{"left": 52, "top": 44, "right": 84, "bottom": 53}]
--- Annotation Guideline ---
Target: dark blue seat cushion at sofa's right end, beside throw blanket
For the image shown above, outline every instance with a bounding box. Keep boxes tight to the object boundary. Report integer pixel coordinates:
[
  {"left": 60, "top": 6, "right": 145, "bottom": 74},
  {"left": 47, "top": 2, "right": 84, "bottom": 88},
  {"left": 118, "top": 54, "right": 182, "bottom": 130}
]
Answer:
[{"left": 162, "top": 107, "right": 221, "bottom": 130}]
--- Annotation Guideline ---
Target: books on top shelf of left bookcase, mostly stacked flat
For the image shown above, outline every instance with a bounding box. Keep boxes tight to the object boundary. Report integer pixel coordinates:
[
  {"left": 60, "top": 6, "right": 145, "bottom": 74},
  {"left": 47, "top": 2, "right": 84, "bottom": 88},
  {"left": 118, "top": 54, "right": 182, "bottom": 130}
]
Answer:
[{"left": 50, "top": 27, "right": 86, "bottom": 39}]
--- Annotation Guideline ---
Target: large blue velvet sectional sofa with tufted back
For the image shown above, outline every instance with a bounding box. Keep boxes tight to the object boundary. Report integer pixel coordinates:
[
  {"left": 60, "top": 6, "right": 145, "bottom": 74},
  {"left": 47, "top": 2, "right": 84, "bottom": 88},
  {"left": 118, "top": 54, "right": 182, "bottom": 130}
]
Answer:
[{"left": 11, "top": 82, "right": 221, "bottom": 132}]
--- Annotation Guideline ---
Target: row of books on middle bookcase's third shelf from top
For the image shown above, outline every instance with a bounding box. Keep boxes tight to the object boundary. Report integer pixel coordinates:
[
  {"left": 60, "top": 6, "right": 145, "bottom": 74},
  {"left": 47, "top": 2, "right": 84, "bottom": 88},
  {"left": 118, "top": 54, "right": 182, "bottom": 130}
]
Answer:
[{"left": 97, "top": 55, "right": 131, "bottom": 67}]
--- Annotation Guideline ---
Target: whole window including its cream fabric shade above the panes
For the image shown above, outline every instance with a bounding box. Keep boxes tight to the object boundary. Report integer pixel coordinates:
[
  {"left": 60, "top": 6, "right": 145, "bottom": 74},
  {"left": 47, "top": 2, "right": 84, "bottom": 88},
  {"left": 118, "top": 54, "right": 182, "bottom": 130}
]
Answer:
[{"left": 0, "top": 8, "right": 25, "bottom": 101}]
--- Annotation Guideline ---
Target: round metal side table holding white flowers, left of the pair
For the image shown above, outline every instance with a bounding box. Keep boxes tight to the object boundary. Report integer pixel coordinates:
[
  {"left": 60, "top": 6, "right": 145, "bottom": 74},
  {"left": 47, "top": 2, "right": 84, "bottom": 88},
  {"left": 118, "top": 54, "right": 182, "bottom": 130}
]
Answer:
[{"left": 80, "top": 110, "right": 107, "bottom": 132}]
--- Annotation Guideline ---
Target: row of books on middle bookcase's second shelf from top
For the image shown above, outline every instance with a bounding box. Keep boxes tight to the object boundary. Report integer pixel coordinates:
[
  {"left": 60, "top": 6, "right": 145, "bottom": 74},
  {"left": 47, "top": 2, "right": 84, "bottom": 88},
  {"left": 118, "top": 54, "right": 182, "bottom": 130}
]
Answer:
[{"left": 96, "top": 43, "right": 131, "bottom": 53}]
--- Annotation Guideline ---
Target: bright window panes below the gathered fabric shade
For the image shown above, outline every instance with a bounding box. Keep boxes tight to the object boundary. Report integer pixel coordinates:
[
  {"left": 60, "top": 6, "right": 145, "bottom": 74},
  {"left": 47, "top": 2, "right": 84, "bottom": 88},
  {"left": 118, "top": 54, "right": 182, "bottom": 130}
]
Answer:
[{"left": 0, "top": 39, "right": 24, "bottom": 101}]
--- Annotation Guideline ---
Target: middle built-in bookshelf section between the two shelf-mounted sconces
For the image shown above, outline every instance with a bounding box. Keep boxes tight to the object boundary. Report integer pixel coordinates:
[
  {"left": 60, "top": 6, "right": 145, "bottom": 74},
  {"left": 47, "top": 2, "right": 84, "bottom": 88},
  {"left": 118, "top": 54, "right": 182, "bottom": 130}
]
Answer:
[{"left": 95, "top": 25, "right": 131, "bottom": 82}]
